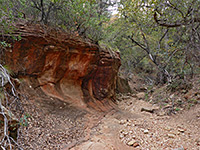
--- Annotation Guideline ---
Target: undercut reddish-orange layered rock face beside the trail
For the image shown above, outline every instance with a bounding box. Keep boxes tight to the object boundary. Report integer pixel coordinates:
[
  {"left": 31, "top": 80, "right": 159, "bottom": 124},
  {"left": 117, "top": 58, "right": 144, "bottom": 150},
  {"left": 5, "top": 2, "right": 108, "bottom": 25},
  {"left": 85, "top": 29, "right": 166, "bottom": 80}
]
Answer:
[{"left": 5, "top": 24, "right": 120, "bottom": 111}]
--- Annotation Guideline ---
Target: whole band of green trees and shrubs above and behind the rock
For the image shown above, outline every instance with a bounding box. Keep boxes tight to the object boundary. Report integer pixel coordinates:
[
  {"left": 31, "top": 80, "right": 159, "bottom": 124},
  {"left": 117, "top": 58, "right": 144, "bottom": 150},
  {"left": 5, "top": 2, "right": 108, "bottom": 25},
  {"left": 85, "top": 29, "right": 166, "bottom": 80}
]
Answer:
[{"left": 0, "top": 0, "right": 200, "bottom": 83}]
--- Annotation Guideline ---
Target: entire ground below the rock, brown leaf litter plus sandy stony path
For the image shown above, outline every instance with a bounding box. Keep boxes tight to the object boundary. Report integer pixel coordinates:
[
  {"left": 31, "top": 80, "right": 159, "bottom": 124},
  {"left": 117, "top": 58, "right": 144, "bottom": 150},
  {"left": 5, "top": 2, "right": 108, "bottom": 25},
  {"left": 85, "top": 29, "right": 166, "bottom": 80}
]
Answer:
[{"left": 18, "top": 82, "right": 200, "bottom": 150}]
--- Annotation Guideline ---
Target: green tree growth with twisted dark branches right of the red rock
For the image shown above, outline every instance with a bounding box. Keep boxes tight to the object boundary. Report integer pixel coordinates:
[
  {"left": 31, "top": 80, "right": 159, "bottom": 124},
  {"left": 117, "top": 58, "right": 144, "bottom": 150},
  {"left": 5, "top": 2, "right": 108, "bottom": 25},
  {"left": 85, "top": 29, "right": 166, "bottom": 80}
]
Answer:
[{"left": 105, "top": 0, "right": 200, "bottom": 83}]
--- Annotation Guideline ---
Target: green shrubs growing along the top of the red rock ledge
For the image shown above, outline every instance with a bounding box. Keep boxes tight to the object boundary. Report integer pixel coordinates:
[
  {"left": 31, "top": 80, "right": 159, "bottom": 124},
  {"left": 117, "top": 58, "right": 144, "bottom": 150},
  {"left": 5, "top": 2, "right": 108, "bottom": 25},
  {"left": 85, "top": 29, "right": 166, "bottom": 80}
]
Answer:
[{"left": 5, "top": 0, "right": 110, "bottom": 42}]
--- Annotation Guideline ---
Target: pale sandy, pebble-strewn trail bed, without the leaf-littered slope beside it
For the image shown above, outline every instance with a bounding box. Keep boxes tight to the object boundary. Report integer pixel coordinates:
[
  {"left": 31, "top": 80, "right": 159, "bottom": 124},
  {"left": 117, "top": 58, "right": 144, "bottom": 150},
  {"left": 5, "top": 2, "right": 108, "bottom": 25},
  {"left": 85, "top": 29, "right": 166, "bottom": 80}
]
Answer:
[{"left": 69, "top": 98, "right": 200, "bottom": 150}]
